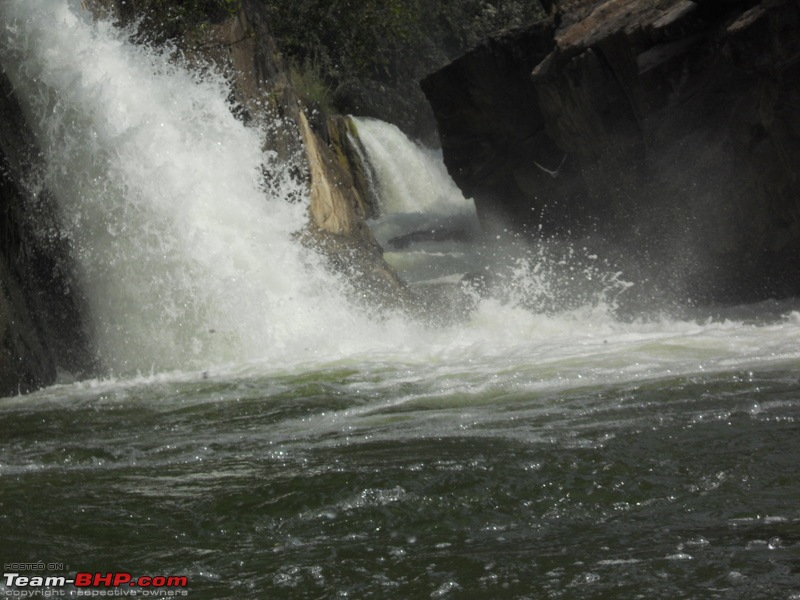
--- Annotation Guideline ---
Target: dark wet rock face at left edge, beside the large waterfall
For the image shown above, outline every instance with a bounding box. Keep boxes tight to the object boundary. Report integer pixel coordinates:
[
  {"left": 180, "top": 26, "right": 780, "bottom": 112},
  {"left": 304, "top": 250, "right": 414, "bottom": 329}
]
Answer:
[{"left": 0, "top": 74, "right": 95, "bottom": 396}]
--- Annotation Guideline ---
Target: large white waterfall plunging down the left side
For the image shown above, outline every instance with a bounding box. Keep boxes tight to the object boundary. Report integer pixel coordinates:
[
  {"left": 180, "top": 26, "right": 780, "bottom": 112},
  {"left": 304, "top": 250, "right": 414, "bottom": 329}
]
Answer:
[{"left": 0, "top": 0, "right": 368, "bottom": 372}]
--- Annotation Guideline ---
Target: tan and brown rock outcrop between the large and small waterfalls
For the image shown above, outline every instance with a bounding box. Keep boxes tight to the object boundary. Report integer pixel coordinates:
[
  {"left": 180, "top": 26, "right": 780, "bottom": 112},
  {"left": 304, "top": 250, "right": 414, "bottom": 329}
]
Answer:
[{"left": 190, "top": 0, "right": 411, "bottom": 306}]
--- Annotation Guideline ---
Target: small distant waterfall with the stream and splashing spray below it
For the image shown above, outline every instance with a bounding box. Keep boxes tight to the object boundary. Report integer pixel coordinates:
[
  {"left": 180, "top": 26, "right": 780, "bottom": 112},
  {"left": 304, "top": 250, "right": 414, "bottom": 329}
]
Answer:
[{"left": 354, "top": 118, "right": 631, "bottom": 318}]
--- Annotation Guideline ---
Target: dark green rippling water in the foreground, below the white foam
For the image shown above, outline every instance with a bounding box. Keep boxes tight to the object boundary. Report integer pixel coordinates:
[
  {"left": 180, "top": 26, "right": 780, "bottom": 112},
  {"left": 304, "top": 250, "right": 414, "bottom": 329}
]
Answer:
[{"left": 0, "top": 361, "right": 800, "bottom": 599}]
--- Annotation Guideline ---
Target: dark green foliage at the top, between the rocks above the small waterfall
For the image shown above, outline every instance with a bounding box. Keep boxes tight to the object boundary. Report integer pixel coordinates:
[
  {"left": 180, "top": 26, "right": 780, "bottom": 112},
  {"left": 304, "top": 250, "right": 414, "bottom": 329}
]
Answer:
[{"left": 259, "top": 0, "right": 543, "bottom": 131}]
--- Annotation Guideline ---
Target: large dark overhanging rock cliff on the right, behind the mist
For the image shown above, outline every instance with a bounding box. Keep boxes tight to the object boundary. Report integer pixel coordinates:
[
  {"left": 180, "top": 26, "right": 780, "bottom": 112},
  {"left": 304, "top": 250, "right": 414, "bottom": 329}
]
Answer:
[{"left": 422, "top": 0, "right": 800, "bottom": 301}]
